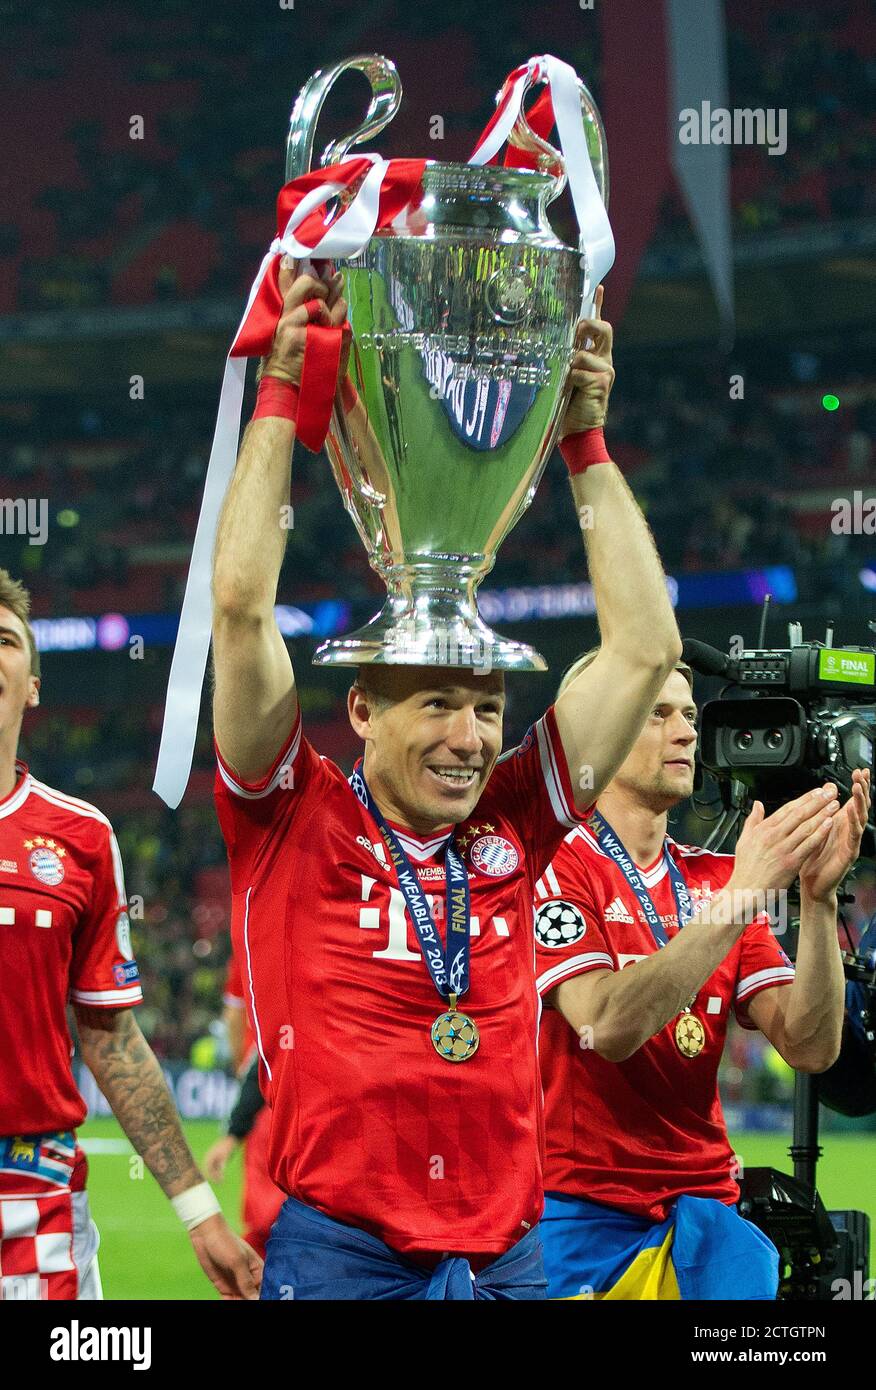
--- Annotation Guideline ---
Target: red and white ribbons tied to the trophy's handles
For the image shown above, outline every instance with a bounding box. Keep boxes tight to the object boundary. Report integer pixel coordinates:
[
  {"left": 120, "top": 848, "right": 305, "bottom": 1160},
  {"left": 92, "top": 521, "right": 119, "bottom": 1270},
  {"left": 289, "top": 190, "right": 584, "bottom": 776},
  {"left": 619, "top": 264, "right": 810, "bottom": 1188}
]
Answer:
[{"left": 153, "top": 54, "right": 615, "bottom": 806}]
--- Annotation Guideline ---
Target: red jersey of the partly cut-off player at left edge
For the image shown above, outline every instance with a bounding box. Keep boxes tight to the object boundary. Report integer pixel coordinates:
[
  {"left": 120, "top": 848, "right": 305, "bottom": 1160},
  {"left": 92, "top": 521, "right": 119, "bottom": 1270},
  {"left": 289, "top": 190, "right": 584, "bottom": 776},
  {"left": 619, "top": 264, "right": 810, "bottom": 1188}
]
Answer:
[{"left": 0, "top": 763, "right": 143, "bottom": 1136}]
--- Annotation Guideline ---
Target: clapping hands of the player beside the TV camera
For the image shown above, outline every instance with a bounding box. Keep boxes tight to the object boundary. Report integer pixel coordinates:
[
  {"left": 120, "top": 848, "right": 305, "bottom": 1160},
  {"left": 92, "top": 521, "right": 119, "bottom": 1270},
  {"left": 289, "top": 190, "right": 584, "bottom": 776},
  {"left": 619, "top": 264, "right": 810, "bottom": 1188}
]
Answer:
[{"left": 730, "top": 783, "right": 838, "bottom": 892}]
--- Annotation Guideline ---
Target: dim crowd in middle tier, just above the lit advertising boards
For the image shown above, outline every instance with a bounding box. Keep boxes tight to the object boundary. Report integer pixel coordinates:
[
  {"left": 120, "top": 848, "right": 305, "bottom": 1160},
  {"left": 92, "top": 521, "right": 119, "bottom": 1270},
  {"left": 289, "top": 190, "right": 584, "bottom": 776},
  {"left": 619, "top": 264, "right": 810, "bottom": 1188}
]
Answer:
[{"left": 0, "top": 342, "right": 876, "bottom": 616}]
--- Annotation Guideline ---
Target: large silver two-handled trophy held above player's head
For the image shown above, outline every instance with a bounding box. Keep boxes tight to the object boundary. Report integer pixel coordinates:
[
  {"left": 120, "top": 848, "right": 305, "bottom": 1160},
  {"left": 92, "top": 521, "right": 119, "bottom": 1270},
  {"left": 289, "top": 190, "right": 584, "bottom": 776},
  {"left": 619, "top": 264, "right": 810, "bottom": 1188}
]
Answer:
[{"left": 286, "top": 56, "right": 613, "bottom": 671}]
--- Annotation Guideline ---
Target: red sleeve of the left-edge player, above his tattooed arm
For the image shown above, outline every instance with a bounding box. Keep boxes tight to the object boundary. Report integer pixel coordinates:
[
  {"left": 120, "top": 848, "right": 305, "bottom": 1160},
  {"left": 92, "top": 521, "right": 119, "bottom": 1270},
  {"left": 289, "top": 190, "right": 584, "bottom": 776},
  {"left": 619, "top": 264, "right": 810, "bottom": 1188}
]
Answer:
[{"left": 70, "top": 820, "right": 143, "bottom": 1009}]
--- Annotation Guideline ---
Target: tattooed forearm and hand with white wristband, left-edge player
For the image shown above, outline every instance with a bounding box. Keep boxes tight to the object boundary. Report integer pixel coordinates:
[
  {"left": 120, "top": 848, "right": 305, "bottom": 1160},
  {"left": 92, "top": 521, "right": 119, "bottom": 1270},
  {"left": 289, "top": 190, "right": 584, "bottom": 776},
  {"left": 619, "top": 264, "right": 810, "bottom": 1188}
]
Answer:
[{"left": 74, "top": 1004, "right": 261, "bottom": 1298}]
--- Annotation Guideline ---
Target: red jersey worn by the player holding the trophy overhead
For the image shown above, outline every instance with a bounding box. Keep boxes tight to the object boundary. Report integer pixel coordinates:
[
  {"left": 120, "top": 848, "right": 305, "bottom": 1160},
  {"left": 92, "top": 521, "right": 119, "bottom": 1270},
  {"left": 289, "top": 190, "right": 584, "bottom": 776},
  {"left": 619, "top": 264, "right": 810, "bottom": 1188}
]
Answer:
[{"left": 216, "top": 710, "right": 580, "bottom": 1255}]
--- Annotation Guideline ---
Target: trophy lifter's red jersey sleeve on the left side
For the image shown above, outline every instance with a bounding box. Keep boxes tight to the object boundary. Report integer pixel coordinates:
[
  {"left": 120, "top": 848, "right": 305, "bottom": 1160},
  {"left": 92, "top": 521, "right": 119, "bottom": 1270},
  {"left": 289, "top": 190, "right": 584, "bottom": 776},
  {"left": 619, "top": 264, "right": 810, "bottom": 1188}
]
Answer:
[{"left": 214, "top": 709, "right": 328, "bottom": 892}]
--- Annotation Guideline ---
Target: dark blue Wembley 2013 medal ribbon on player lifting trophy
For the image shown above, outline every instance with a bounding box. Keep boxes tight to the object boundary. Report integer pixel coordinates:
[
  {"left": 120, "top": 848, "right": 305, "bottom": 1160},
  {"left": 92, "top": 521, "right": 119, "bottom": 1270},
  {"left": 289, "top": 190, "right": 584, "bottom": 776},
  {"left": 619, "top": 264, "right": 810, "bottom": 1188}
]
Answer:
[{"left": 349, "top": 760, "right": 471, "bottom": 999}]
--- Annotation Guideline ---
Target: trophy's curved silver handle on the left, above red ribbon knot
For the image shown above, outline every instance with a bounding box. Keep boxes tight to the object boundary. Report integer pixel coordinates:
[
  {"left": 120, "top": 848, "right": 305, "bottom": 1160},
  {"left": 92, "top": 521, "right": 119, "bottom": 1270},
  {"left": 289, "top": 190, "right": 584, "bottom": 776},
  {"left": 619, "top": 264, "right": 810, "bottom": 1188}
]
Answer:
[{"left": 286, "top": 53, "right": 402, "bottom": 182}]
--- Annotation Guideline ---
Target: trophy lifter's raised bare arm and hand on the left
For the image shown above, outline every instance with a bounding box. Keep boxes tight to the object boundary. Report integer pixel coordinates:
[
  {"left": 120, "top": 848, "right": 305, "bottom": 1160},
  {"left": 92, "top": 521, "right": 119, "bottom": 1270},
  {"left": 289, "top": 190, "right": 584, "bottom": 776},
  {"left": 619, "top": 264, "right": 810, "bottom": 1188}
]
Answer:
[{"left": 213, "top": 262, "right": 346, "bottom": 781}]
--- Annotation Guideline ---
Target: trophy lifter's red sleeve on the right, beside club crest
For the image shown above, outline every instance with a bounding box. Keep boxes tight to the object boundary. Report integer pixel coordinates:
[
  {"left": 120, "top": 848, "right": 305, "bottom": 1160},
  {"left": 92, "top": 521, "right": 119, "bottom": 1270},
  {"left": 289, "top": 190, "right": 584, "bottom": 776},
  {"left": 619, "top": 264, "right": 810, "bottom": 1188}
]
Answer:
[{"left": 478, "top": 705, "right": 592, "bottom": 880}]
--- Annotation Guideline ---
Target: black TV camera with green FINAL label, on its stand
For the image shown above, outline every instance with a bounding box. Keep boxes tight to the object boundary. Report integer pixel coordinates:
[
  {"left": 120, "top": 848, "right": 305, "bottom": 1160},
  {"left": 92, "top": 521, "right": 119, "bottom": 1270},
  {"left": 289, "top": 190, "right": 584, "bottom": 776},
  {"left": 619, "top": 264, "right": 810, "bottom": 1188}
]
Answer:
[{"left": 683, "top": 614, "right": 876, "bottom": 1300}]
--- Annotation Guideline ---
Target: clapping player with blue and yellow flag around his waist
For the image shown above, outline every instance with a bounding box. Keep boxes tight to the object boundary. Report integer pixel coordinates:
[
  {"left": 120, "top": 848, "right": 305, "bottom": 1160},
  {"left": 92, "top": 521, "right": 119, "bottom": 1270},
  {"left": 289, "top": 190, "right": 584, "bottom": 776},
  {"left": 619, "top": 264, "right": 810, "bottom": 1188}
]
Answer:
[{"left": 535, "top": 652, "right": 869, "bottom": 1300}]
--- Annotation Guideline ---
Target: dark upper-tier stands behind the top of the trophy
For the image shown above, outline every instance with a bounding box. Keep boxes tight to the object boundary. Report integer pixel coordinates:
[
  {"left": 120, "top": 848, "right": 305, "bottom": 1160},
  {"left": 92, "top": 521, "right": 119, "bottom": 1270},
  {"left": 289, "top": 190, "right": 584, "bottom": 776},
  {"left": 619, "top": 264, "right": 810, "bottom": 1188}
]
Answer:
[{"left": 0, "top": 0, "right": 876, "bottom": 311}]
